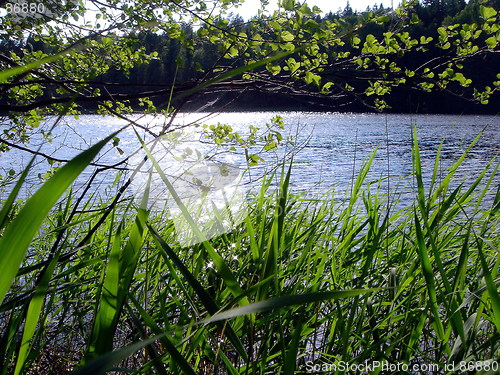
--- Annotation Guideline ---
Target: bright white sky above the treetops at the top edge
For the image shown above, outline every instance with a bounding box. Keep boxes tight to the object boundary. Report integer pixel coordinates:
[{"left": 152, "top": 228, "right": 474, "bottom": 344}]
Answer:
[{"left": 230, "top": 0, "right": 400, "bottom": 19}]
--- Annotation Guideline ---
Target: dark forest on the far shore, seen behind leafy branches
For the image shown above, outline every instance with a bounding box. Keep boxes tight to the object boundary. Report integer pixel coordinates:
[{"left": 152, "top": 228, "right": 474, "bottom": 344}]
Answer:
[{"left": 0, "top": 0, "right": 500, "bottom": 114}]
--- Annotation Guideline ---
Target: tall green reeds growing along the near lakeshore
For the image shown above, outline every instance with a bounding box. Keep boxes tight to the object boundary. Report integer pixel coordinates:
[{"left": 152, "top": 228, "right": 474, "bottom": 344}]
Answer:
[{"left": 0, "top": 128, "right": 500, "bottom": 374}]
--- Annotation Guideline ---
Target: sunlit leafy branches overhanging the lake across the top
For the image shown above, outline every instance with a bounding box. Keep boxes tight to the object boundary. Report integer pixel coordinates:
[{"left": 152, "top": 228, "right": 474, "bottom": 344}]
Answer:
[{"left": 0, "top": 0, "right": 500, "bottom": 152}]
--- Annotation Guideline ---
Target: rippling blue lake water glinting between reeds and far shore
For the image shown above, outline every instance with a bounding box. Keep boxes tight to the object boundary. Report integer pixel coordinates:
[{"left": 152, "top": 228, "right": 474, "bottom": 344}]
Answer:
[{"left": 0, "top": 112, "right": 500, "bottom": 210}]
